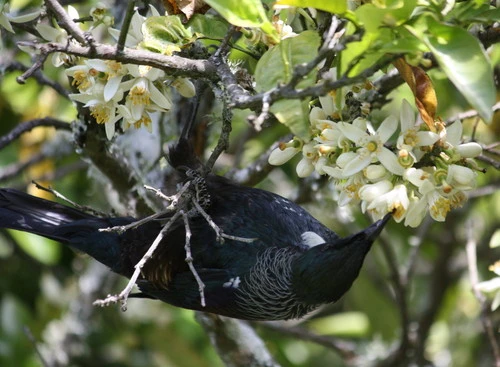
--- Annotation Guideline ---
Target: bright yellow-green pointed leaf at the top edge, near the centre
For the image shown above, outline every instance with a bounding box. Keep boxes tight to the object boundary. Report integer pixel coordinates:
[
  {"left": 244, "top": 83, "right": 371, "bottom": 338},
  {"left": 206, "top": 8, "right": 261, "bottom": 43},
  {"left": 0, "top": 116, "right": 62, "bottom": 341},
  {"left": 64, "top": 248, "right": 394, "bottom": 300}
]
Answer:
[{"left": 205, "top": 0, "right": 279, "bottom": 42}]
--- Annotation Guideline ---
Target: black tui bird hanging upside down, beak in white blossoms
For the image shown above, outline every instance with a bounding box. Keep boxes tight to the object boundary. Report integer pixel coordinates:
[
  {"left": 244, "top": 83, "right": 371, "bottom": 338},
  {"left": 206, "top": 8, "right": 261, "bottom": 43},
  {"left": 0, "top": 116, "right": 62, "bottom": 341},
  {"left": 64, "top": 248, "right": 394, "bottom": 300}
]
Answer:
[{"left": 0, "top": 98, "right": 390, "bottom": 320}]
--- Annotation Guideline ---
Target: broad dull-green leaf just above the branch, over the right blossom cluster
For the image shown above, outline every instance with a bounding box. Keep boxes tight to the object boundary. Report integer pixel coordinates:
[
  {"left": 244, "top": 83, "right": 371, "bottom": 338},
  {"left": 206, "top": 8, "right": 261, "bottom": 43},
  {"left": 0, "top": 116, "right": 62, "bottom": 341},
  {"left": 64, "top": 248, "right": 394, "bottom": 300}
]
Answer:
[{"left": 255, "top": 31, "right": 320, "bottom": 92}]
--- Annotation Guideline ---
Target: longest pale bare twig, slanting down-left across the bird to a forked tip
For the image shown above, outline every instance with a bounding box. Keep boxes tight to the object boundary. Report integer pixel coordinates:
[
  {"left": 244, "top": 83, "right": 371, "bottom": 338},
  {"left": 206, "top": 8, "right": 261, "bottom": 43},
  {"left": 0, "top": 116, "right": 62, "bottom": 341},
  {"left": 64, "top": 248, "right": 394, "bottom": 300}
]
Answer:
[{"left": 94, "top": 211, "right": 182, "bottom": 311}]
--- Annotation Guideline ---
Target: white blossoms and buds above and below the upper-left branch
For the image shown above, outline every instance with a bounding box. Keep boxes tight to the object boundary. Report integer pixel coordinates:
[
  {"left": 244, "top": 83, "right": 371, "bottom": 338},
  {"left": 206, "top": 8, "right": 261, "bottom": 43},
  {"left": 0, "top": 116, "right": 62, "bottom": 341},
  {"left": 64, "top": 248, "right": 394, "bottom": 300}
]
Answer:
[{"left": 0, "top": 4, "right": 195, "bottom": 139}]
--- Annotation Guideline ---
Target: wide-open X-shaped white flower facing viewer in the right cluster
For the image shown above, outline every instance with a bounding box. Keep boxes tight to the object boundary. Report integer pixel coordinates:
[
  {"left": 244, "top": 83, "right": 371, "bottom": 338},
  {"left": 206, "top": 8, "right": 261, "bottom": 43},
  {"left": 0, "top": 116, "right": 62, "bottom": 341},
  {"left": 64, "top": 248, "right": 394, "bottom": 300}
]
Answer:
[{"left": 338, "top": 116, "right": 404, "bottom": 176}]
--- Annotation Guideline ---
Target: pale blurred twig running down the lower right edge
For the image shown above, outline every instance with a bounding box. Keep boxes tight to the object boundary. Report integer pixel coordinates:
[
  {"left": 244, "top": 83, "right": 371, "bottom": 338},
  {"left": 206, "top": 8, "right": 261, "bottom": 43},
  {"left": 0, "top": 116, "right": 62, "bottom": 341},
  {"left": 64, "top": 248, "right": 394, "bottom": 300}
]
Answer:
[{"left": 465, "top": 221, "right": 500, "bottom": 367}]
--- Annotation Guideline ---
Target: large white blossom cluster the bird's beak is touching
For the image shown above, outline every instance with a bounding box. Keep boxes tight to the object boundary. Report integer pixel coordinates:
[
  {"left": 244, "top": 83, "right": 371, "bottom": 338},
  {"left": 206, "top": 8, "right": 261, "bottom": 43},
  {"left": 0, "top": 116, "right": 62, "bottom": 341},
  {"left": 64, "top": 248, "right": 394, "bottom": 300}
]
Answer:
[{"left": 269, "top": 96, "right": 482, "bottom": 227}]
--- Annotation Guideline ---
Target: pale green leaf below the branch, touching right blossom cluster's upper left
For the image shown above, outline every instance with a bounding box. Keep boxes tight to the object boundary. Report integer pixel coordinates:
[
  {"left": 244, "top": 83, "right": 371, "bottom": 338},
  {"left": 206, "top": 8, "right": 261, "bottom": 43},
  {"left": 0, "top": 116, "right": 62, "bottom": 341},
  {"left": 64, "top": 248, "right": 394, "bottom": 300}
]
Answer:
[{"left": 270, "top": 99, "right": 311, "bottom": 141}]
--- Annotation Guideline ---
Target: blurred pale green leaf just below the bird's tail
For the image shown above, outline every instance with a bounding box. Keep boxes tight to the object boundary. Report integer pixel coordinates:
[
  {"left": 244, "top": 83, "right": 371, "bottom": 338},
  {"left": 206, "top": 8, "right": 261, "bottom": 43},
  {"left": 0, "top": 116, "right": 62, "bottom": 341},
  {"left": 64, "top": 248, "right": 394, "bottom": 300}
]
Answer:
[{"left": 9, "top": 230, "right": 61, "bottom": 265}]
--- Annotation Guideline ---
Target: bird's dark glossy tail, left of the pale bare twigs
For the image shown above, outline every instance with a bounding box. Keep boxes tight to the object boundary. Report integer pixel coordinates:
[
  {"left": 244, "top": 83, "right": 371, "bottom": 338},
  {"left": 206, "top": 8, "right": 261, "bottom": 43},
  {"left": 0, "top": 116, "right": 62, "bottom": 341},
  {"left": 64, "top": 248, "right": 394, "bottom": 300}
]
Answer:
[{"left": 0, "top": 189, "right": 132, "bottom": 273}]
